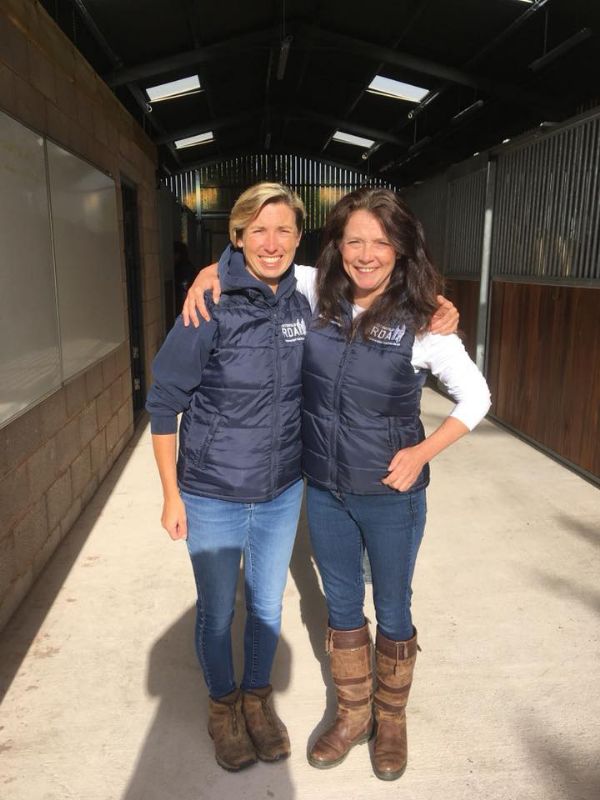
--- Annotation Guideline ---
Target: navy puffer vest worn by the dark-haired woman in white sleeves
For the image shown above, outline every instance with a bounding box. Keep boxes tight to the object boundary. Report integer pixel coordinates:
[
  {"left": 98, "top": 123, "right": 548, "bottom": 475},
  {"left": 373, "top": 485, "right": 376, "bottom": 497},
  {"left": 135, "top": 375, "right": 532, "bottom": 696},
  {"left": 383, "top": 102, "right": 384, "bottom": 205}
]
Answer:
[{"left": 302, "top": 311, "right": 429, "bottom": 494}]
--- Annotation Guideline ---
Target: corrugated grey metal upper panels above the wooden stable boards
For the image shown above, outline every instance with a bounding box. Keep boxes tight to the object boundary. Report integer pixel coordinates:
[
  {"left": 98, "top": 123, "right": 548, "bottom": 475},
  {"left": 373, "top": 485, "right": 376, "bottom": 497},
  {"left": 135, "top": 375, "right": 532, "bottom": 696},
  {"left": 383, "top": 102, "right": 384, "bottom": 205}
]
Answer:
[{"left": 403, "top": 103, "right": 600, "bottom": 346}]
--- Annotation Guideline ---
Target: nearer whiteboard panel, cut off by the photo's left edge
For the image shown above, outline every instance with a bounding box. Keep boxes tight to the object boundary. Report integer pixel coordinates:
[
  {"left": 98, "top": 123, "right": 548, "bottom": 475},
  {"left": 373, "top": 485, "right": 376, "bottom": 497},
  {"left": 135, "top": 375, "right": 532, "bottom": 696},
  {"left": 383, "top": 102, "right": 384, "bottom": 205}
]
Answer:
[{"left": 0, "top": 112, "right": 61, "bottom": 423}]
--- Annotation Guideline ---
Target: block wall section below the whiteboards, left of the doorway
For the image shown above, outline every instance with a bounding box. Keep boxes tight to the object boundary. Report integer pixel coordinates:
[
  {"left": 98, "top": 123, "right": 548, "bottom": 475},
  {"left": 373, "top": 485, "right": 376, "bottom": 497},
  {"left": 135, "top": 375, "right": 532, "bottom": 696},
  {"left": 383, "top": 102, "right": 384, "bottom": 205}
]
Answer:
[{"left": 0, "top": 343, "right": 133, "bottom": 628}]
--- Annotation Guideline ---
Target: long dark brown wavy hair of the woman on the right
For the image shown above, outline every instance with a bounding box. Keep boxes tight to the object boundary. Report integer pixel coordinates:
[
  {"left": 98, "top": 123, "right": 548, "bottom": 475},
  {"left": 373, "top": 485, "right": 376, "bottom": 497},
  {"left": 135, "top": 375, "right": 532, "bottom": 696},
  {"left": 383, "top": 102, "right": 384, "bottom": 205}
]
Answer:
[{"left": 316, "top": 187, "right": 442, "bottom": 336}]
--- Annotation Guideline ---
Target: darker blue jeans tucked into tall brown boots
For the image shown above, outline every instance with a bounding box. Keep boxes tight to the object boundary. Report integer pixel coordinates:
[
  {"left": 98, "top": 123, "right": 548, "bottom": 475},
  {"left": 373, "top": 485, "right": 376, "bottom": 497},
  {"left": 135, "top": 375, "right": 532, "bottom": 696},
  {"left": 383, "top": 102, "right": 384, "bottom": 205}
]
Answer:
[{"left": 306, "top": 485, "right": 426, "bottom": 641}]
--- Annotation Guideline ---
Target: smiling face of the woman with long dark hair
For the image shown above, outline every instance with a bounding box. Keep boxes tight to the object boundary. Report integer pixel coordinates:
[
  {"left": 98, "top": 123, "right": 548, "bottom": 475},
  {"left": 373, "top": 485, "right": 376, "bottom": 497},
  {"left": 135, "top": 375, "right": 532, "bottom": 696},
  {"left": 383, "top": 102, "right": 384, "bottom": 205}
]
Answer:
[{"left": 339, "top": 210, "right": 396, "bottom": 308}]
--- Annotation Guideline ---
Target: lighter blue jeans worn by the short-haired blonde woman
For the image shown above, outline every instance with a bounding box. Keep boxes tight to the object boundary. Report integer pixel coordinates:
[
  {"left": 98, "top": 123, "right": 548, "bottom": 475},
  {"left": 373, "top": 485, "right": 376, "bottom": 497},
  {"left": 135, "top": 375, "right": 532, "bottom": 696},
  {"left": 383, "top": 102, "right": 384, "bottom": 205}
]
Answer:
[{"left": 181, "top": 480, "right": 303, "bottom": 699}]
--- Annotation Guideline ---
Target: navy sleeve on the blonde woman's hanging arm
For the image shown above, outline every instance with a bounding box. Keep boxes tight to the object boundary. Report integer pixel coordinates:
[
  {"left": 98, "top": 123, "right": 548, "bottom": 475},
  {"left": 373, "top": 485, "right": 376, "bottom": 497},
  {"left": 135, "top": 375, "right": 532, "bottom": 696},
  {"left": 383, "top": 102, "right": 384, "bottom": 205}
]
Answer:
[{"left": 146, "top": 317, "right": 217, "bottom": 434}]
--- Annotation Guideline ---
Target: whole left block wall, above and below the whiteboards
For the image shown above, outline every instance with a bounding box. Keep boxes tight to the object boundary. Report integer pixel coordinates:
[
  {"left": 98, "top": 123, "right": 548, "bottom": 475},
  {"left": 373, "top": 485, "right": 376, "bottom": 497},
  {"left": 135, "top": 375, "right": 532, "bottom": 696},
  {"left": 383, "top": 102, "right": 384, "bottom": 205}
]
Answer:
[{"left": 0, "top": 0, "right": 162, "bottom": 629}]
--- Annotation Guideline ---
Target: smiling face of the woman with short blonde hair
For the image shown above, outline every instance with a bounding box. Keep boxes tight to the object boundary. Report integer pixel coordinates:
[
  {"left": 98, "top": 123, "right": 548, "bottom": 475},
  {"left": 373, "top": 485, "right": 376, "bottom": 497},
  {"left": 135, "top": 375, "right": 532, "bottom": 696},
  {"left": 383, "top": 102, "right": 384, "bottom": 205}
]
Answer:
[{"left": 237, "top": 203, "right": 301, "bottom": 292}]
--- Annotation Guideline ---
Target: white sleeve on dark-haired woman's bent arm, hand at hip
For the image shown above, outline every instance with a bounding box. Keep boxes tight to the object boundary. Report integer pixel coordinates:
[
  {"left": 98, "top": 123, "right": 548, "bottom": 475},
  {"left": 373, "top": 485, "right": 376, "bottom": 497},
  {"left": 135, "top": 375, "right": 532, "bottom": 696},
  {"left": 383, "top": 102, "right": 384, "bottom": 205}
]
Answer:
[{"left": 412, "top": 333, "right": 491, "bottom": 430}]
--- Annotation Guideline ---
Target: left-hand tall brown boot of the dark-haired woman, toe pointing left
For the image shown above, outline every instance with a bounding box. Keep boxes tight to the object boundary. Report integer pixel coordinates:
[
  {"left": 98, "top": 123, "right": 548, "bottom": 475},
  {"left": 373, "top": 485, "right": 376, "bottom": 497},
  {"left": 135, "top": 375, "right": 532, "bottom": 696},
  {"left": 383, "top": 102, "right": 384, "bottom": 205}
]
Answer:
[{"left": 308, "top": 624, "right": 373, "bottom": 769}]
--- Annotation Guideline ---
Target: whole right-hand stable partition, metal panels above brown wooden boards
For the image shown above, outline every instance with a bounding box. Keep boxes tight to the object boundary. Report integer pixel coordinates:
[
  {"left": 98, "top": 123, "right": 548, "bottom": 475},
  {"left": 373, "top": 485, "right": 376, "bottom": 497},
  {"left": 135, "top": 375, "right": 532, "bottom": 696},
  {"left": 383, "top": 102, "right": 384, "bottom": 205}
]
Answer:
[{"left": 405, "top": 109, "right": 600, "bottom": 483}]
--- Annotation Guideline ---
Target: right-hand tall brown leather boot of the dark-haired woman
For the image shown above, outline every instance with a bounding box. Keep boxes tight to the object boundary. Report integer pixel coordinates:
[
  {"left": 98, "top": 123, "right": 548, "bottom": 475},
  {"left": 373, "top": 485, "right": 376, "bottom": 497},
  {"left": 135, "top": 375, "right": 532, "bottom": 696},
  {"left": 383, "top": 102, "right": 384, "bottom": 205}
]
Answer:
[{"left": 373, "top": 628, "right": 417, "bottom": 781}]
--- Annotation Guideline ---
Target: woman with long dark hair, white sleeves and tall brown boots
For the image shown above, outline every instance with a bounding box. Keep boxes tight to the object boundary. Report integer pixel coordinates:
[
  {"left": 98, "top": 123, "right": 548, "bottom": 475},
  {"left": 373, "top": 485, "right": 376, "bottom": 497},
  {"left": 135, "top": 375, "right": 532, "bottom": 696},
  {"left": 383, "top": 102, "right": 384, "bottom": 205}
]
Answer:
[{"left": 302, "top": 189, "right": 489, "bottom": 780}]
